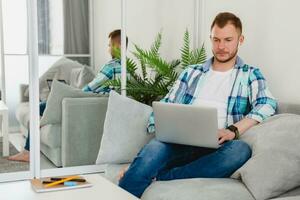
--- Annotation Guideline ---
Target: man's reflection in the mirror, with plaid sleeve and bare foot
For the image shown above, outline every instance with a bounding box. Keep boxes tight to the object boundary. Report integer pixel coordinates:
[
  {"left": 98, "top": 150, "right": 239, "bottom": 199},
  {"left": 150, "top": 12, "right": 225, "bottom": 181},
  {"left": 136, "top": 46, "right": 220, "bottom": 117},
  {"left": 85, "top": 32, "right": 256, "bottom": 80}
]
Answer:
[{"left": 8, "top": 29, "right": 128, "bottom": 162}]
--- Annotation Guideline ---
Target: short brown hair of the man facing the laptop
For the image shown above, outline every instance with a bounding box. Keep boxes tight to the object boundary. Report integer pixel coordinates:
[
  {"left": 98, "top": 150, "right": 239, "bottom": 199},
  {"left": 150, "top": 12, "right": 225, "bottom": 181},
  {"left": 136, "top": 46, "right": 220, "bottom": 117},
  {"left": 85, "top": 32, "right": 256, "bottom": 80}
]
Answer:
[{"left": 210, "top": 12, "right": 242, "bottom": 34}]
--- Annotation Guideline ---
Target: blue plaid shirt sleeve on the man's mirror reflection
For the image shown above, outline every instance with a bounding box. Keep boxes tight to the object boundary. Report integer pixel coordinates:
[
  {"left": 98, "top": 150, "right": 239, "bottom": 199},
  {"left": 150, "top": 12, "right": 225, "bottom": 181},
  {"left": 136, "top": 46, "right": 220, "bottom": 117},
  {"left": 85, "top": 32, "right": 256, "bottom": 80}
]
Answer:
[{"left": 82, "top": 65, "right": 114, "bottom": 92}]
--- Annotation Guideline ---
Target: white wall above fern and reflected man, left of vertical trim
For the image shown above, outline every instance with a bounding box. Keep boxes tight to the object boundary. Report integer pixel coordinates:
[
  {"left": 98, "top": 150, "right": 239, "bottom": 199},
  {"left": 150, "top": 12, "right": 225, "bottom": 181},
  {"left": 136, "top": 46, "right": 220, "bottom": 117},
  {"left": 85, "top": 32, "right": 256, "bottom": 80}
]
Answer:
[{"left": 94, "top": 0, "right": 194, "bottom": 69}]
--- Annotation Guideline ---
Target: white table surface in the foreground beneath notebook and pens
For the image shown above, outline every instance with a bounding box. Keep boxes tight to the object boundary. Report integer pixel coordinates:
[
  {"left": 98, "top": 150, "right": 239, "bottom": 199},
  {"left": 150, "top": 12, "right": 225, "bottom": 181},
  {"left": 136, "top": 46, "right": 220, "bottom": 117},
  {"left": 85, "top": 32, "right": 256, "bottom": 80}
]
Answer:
[{"left": 0, "top": 174, "right": 138, "bottom": 200}]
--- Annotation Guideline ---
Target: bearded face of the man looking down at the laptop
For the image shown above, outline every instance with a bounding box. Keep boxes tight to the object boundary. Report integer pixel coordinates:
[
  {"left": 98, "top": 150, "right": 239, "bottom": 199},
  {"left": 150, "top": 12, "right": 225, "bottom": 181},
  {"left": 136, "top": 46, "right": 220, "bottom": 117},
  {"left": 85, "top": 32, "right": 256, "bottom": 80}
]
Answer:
[{"left": 210, "top": 23, "right": 244, "bottom": 63}]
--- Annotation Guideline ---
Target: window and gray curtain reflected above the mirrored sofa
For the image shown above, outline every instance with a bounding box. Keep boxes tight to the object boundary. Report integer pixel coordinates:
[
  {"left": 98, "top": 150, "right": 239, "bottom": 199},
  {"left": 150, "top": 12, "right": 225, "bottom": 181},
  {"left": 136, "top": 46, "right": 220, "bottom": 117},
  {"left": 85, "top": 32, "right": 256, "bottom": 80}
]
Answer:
[{"left": 37, "top": 0, "right": 89, "bottom": 55}]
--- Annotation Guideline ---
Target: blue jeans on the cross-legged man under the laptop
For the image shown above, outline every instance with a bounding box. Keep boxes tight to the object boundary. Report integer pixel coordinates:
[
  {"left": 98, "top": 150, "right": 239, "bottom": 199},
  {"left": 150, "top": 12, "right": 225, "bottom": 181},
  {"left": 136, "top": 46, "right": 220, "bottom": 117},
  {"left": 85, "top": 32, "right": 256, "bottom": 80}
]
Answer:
[{"left": 119, "top": 139, "right": 251, "bottom": 197}]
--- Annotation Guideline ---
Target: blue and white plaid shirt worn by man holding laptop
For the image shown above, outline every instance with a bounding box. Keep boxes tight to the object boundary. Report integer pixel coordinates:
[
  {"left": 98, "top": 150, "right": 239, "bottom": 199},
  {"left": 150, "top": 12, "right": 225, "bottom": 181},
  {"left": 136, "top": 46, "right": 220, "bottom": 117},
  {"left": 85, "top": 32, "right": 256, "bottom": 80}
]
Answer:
[{"left": 147, "top": 57, "right": 277, "bottom": 133}]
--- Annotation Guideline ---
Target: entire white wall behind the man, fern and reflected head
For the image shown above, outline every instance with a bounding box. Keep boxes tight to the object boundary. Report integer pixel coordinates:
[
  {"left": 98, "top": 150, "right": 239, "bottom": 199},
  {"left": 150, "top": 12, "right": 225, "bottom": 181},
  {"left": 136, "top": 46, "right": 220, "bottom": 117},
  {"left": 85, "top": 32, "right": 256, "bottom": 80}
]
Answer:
[{"left": 94, "top": 0, "right": 300, "bottom": 103}]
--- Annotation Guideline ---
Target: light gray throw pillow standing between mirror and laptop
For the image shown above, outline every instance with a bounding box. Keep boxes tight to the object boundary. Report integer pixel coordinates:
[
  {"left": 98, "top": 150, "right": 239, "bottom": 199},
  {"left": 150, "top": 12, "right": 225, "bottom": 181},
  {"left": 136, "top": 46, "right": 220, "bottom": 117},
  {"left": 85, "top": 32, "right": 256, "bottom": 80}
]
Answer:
[{"left": 96, "top": 91, "right": 153, "bottom": 164}]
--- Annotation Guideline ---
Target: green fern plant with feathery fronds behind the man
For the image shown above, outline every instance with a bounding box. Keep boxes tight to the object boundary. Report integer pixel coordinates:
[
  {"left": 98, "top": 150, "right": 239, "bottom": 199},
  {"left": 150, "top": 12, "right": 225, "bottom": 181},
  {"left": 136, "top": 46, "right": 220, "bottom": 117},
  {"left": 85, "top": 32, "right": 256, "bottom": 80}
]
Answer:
[{"left": 105, "top": 30, "right": 206, "bottom": 105}]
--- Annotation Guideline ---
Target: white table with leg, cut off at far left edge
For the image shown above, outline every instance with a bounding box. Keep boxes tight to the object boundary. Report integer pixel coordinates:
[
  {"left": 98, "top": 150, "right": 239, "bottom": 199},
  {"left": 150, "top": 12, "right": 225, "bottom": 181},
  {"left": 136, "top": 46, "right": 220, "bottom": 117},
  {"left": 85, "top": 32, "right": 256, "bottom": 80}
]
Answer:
[{"left": 0, "top": 101, "right": 9, "bottom": 156}]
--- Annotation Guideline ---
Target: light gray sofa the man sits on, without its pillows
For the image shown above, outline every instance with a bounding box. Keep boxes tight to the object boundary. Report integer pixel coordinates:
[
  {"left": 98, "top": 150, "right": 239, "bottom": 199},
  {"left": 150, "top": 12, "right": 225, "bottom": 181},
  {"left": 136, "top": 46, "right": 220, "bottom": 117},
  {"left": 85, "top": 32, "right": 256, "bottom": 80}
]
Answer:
[{"left": 104, "top": 103, "right": 300, "bottom": 200}]
